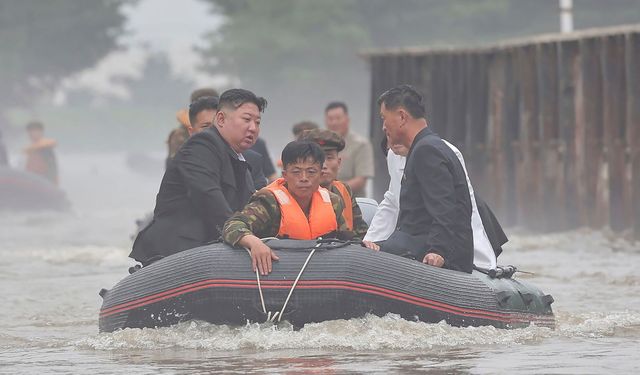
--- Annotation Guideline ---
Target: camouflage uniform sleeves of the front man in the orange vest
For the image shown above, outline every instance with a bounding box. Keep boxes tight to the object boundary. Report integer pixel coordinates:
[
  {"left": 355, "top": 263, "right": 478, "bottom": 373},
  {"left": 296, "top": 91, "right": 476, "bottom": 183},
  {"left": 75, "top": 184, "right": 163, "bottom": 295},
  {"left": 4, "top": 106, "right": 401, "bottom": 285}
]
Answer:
[{"left": 222, "top": 188, "right": 361, "bottom": 246}]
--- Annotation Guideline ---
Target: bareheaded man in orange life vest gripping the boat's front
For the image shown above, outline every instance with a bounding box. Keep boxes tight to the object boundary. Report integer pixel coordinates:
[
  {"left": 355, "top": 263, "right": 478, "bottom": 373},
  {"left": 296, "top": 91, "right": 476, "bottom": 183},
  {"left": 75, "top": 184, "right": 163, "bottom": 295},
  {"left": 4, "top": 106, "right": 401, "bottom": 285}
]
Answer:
[{"left": 222, "top": 141, "right": 354, "bottom": 275}]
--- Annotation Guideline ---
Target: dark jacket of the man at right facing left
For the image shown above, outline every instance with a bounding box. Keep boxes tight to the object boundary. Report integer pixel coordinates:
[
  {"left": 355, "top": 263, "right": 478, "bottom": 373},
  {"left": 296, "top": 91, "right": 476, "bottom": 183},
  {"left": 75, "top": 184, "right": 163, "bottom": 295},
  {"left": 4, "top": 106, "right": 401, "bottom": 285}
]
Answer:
[{"left": 382, "top": 128, "right": 473, "bottom": 272}]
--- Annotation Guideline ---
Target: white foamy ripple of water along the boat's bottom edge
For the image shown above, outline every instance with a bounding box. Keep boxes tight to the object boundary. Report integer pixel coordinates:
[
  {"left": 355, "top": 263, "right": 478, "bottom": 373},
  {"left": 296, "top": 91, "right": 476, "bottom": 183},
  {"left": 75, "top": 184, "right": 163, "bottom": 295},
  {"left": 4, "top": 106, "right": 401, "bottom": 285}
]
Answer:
[{"left": 73, "top": 312, "right": 640, "bottom": 351}]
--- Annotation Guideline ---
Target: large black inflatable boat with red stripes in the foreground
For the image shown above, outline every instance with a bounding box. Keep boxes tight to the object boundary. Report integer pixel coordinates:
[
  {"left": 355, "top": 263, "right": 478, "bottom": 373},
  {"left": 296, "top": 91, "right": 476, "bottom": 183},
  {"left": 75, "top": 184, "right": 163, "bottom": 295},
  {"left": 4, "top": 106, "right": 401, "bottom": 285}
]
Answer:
[{"left": 99, "top": 239, "right": 555, "bottom": 332}]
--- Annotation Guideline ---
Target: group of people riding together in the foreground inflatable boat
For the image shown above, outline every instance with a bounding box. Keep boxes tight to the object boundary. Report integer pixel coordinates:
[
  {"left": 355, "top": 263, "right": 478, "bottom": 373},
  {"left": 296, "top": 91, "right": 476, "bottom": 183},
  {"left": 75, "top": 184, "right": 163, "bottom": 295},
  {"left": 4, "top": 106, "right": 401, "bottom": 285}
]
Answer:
[{"left": 130, "top": 85, "right": 506, "bottom": 275}]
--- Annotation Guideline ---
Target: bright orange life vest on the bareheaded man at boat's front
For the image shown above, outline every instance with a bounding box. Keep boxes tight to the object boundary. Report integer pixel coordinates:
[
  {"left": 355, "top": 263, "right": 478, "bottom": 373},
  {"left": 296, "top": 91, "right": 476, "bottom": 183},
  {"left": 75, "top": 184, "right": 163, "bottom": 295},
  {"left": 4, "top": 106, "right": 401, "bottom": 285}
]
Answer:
[{"left": 266, "top": 178, "right": 338, "bottom": 240}]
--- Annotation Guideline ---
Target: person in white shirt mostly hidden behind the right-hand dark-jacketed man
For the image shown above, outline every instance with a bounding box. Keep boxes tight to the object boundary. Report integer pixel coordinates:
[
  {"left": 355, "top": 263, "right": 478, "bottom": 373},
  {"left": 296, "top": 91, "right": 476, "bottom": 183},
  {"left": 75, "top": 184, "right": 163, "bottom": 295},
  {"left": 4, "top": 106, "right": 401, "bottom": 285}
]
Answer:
[{"left": 362, "top": 140, "right": 497, "bottom": 269}]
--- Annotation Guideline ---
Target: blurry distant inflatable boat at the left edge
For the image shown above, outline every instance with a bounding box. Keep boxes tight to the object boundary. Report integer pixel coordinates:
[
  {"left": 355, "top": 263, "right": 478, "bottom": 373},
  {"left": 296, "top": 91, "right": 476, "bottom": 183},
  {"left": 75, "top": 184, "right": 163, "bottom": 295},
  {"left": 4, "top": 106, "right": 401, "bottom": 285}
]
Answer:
[{"left": 0, "top": 167, "right": 70, "bottom": 211}]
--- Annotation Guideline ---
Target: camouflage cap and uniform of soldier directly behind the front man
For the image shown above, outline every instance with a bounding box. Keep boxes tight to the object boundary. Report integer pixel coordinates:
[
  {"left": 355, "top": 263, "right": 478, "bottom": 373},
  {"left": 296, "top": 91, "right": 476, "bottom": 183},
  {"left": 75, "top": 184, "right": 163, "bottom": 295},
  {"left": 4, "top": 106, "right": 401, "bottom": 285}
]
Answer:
[{"left": 300, "top": 129, "right": 369, "bottom": 239}]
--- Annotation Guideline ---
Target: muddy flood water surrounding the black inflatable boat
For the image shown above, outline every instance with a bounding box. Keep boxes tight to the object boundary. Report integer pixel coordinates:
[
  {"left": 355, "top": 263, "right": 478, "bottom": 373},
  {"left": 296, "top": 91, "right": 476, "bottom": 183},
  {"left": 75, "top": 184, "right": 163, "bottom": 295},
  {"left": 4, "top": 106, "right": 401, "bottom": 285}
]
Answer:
[{"left": 0, "top": 154, "right": 640, "bottom": 374}]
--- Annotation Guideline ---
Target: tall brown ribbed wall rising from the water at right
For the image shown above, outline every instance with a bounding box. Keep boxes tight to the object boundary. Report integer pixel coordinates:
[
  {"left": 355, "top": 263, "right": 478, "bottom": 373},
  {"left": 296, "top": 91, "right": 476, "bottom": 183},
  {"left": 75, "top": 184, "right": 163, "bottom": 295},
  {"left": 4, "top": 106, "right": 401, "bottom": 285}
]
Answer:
[{"left": 363, "top": 25, "right": 640, "bottom": 238}]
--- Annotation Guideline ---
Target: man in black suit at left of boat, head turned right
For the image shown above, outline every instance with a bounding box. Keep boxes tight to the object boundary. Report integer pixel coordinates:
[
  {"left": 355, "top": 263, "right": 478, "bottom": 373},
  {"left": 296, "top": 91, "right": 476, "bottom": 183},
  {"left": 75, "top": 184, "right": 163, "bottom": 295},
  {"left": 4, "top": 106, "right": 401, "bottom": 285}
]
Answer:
[{"left": 129, "top": 89, "right": 267, "bottom": 265}]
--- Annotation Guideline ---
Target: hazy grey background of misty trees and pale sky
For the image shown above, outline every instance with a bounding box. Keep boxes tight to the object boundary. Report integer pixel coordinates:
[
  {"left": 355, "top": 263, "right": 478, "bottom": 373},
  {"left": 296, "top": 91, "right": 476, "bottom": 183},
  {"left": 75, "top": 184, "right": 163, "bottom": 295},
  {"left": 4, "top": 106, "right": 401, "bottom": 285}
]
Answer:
[{"left": 0, "top": 0, "right": 640, "bottom": 160}]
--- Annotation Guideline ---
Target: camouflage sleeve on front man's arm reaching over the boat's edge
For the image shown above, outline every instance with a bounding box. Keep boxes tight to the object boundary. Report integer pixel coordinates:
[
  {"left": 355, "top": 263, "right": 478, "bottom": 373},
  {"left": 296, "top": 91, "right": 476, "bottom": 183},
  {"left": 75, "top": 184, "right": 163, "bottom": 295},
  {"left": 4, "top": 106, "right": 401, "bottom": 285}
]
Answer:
[{"left": 222, "top": 191, "right": 280, "bottom": 246}]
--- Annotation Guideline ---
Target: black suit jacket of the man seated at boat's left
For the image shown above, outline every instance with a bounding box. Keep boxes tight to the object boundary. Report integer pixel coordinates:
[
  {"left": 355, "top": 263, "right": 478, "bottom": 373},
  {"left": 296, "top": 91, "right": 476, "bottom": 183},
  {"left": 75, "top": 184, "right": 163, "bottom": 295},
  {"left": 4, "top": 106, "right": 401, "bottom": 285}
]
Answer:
[{"left": 129, "top": 128, "right": 254, "bottom": 265}]
